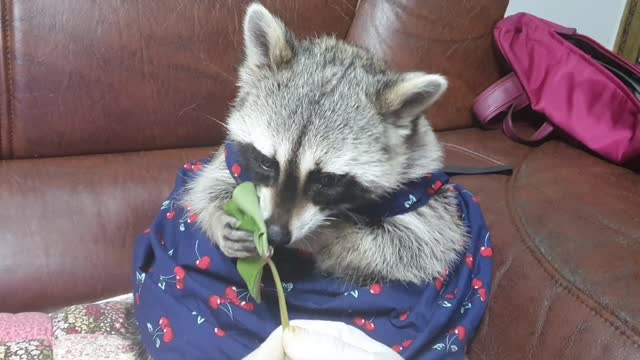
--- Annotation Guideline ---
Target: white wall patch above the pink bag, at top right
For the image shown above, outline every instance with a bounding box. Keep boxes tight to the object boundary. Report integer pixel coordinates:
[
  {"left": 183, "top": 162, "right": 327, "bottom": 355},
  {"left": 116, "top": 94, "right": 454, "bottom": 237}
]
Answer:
[{"left": 507, "top": 0, "right": 626, "bottom": 49}]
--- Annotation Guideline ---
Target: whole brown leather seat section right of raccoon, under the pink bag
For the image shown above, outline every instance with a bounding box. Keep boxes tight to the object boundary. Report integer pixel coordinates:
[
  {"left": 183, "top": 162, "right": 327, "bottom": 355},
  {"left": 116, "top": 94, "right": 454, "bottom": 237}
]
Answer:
[{"left": 440, "top": 129, "right": 640, "bottom": 360}]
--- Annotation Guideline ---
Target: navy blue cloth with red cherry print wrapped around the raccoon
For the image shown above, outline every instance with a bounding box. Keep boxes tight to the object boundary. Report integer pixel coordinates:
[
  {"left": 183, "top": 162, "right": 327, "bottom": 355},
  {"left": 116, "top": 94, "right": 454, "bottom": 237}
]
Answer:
[{"left": 132, "top": 144, "right": 500, "bottom": 359}]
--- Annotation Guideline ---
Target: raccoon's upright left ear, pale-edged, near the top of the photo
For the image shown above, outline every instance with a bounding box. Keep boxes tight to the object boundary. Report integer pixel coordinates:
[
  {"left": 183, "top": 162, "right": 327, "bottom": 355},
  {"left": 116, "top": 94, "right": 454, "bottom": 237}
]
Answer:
[{"left": 244, "top": 3, "right": 293, "bottom": 70}]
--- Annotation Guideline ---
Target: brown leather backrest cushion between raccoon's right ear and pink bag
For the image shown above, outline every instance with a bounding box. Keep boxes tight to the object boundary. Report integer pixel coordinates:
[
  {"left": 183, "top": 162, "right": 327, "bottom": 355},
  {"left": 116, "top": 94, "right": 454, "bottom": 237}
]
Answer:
[{"left": 347, "top": 0, "right": 509, "bottom": 130}]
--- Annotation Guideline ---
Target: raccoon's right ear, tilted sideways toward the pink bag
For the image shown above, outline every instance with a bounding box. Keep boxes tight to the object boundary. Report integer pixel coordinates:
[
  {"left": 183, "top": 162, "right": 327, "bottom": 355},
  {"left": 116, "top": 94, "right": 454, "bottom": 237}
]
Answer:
[{"left": 378, "top": 72, "right": 447, "bottom": 127}]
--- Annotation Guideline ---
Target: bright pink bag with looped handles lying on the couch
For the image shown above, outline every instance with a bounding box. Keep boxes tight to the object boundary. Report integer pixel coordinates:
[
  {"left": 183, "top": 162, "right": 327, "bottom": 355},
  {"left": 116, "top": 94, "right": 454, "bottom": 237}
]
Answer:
[{"left": 473, "top": 13, "right": 640, "bottom": 164}]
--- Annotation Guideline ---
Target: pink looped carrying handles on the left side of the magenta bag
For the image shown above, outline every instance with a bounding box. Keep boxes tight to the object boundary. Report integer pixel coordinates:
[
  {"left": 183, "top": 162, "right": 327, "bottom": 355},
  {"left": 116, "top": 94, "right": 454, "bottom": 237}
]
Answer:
[{"left": 473, "top": 73, "right": 554, "bottom": 145}]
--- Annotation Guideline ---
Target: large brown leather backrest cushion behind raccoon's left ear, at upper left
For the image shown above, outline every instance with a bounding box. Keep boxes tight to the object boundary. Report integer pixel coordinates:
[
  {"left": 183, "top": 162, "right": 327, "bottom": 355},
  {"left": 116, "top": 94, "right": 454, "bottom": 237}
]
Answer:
[{"left": 0, "top": 0, "right": 357, "bottom": 159}]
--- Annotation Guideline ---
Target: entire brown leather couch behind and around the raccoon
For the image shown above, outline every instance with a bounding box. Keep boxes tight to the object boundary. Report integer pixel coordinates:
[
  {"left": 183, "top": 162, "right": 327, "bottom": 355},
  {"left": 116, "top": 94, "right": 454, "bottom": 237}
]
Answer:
[{"left": 0, "top": 0, "right": 640, "bottom": 359}]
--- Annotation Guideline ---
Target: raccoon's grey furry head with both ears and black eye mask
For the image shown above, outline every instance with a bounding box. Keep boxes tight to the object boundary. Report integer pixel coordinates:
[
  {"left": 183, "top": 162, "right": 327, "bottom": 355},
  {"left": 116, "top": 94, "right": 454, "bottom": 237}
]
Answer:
[{"left": 228, "top": 4, "right": 446, "bottom": 245}]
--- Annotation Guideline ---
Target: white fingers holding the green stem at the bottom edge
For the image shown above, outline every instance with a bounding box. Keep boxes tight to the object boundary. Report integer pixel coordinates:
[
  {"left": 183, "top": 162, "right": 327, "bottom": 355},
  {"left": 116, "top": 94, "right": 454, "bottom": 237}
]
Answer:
[{"left": 245, "top": 320, "right": 402, "bottom": 360}]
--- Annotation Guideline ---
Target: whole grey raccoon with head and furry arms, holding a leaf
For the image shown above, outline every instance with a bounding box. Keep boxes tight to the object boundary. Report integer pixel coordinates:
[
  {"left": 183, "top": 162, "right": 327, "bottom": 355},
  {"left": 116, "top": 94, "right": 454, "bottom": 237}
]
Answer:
[{"left": 184, "top": 3, "right": 467, "bottom": 284}]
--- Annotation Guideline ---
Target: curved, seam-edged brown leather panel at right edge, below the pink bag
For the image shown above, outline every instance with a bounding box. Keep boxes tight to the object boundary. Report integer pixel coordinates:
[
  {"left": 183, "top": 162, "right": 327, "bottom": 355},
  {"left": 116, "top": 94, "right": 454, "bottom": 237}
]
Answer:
[{"left": 511, "top": 143, "right": 640, "bottom": 330}]
